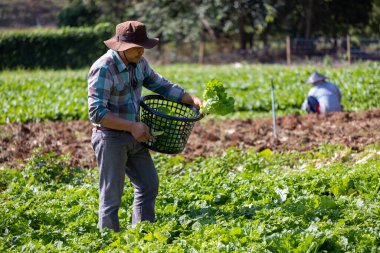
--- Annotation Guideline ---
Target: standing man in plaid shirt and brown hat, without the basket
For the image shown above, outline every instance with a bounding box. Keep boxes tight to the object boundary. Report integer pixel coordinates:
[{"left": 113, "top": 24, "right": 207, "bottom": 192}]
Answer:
[{"left": 88, "top": 21, "right": 202, "bottom": 231}]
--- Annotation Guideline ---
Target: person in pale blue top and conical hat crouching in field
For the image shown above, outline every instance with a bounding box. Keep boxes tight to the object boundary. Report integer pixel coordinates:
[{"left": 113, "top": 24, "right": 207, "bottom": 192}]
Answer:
[{"left": 301, "top": 71, "right": 342, "bottom": 113}]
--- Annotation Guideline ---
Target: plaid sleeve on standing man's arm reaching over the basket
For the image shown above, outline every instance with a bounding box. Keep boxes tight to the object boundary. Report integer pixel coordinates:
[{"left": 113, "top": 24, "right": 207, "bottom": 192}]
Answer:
[{"left": 143, "top": 59, "right": 185, "bottom": 102}]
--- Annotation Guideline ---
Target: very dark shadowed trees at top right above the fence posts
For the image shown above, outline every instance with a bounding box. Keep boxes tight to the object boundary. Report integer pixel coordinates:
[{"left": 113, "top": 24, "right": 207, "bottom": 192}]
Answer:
[{"left": 268, "top": 0, "right": 372, "bottom": 38}]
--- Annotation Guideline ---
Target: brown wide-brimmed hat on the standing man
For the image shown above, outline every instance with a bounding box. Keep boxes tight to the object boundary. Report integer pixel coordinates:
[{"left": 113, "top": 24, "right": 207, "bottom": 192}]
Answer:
[{"left": 104, "top": 21, "right": 158, "bottom": 51}]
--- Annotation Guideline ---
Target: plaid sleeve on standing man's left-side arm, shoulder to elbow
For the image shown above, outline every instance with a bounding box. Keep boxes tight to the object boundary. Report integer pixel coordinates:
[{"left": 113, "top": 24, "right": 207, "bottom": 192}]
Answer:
[{"left": 88, "top": 66, "right": 112, "bottom": 125}]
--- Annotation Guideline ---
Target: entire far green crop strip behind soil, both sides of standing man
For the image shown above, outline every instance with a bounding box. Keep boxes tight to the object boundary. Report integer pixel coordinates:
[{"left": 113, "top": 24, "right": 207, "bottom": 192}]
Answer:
[{"left": 0, "top": 63, "right": 380, "bottom": 123}]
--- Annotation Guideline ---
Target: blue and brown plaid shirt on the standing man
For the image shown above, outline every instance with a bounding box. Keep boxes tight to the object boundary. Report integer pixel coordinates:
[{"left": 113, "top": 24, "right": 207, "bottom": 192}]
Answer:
[{"left": 88, "top": 49, "right": 184, "bottom": 126}]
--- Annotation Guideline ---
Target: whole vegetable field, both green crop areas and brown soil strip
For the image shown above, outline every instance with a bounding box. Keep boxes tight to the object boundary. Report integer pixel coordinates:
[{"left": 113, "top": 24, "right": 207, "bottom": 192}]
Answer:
[{"left": 0, "top": 63, "right": 380, "bottom": 253}]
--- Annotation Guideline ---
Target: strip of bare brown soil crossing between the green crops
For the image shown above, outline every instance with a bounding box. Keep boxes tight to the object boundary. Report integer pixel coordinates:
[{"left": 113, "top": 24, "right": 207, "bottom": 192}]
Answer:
[{"left": 0, "top": 109, "right": 380, "bottom": 168}]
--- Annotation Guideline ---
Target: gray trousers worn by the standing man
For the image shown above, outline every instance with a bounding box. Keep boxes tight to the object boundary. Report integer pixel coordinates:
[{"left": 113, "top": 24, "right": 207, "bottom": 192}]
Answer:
[{"left": 91, "top": 129, "right": 158, "bottom": 231}]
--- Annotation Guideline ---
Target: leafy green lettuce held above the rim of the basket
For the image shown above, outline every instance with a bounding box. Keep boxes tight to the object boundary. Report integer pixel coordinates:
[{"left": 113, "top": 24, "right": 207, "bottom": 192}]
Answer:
[{"left": 201, "top": 79, "right": 235, "bottom": 115}]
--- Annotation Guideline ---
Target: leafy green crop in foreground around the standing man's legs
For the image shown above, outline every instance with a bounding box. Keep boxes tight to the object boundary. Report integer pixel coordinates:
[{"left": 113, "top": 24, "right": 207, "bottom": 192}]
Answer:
[{"left": 0, "top": 145, "right": 380, "bottom": 252}]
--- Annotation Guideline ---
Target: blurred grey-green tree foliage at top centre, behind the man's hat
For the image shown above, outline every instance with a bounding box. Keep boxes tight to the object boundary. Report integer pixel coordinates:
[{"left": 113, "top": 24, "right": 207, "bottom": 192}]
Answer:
[{"left": 132, "top": 0, "right": 273, "bottom": 50}]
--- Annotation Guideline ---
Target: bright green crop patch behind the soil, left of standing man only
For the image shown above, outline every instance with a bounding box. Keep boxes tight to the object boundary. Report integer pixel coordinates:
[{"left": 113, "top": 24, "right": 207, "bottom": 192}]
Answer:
[{"left": 0, "top": 70, "right": 88, "bottom": 123}]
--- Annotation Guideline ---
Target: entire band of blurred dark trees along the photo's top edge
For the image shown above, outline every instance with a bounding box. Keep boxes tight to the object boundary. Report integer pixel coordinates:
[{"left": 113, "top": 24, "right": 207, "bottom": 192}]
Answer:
[{"left": 0, "top": 0, "right": 380, "bottom": 50}]
